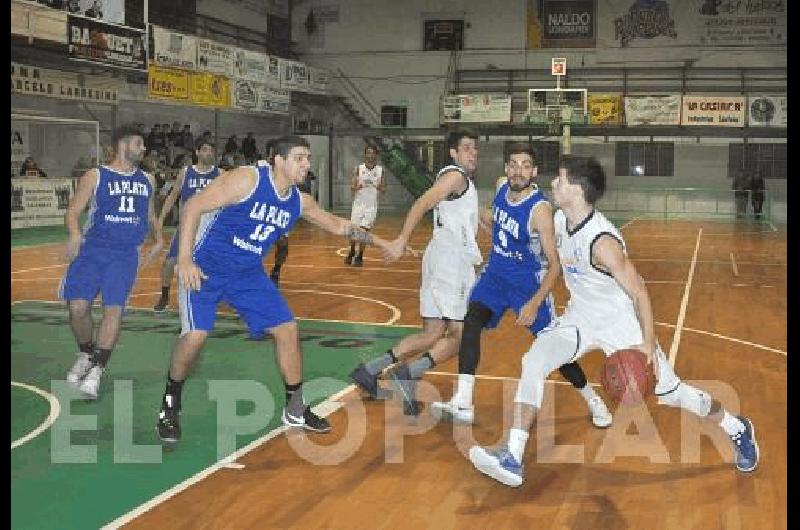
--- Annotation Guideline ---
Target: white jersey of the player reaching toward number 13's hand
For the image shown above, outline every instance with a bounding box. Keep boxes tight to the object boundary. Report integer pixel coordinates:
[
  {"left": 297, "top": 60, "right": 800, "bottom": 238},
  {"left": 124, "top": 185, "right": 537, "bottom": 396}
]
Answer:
[{"left": 429, "top": 166, "right": 483, "bottom": 265}]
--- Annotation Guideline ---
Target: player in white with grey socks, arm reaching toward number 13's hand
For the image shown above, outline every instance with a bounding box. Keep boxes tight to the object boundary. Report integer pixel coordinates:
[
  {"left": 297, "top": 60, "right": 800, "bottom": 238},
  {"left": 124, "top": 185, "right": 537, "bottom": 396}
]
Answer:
[{"left": 350, "top": 130, "right": 482, "bottom": 416}]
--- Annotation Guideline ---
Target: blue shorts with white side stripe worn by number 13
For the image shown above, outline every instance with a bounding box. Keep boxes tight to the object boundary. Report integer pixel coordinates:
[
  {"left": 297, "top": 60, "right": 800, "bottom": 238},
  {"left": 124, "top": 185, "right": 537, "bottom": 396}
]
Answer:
[{"left": 178, "top": 266, "right": 294, "bottom": 337}]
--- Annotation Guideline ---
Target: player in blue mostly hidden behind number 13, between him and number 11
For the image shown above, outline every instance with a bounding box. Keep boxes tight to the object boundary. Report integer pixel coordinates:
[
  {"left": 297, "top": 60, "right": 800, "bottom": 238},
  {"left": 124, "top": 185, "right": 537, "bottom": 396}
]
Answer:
[{"left": 153, "top": 138, "right": 220, "bottom": 313}]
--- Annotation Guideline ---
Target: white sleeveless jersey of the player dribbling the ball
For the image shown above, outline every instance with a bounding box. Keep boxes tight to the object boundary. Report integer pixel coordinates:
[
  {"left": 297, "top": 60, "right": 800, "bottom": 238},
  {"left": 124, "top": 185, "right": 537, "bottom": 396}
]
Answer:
[{"left": 553, "top": 206, "right": 635, "bottom": 326}]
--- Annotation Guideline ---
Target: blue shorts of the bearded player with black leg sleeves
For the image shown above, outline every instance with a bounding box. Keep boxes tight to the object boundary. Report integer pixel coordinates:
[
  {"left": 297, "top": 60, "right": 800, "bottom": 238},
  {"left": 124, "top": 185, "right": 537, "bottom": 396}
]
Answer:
[{"left": 469, "top": 266, "right": 555, "bottom": 334}]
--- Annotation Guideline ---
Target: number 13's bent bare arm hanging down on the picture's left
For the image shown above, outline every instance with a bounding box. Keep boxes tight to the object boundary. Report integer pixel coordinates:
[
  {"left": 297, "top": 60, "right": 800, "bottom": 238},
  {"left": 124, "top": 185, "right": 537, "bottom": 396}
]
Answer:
[{"left": 177, "top": 166, "right": 258, "bottom": 290}]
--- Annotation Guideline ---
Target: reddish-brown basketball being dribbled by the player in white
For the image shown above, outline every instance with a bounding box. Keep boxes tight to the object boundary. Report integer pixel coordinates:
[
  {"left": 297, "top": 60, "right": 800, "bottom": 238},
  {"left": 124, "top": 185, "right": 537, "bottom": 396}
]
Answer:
[{"left": 600, "top": 349, "right": 655, "bottom": 405}]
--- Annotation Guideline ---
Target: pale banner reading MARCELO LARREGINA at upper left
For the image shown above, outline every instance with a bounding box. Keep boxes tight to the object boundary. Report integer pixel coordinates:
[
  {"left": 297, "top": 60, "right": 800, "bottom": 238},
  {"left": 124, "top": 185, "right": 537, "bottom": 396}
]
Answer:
[{"left": 11, "top": 63, "right": 124, "bottom": 104}]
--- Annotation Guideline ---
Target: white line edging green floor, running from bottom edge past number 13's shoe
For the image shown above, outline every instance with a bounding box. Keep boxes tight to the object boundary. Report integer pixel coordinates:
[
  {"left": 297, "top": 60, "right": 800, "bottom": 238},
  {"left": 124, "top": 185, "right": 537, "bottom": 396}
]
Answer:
[{"left": 101, "top": 385, "right": 355, "bottom": 530}]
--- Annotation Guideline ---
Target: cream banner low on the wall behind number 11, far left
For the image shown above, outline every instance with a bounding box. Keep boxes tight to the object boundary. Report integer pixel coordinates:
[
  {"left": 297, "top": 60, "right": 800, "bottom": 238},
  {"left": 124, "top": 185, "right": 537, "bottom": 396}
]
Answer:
[{"left": 11, "top": 178, "right": 74, "bottom": 228}]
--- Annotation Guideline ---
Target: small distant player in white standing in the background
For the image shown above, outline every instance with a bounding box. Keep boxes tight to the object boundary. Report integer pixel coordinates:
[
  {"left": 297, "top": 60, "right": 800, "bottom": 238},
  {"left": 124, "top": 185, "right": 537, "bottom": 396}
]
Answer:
[{"left": 344, "top": 145, "right": 386, "bottom": 267}]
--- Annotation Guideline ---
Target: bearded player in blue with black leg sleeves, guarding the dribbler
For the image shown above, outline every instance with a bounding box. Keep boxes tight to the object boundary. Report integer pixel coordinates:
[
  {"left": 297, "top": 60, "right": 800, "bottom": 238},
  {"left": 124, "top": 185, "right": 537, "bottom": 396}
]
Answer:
[{"left": 431, "top": 143, "right": 612, "bottom": 428}]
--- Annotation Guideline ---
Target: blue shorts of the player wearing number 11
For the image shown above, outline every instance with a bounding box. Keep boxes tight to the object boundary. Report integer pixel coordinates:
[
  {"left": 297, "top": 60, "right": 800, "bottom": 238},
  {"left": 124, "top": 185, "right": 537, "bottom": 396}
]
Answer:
[{"left": 58, "top": 244, "right": 139, "bottom": 307}]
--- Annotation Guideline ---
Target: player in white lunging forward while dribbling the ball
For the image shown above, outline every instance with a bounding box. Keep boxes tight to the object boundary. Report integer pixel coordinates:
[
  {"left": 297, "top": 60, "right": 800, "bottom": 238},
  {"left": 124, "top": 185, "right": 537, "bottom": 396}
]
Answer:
[{"left": 469, "top": 155, "right": 759, "bottom": 487}]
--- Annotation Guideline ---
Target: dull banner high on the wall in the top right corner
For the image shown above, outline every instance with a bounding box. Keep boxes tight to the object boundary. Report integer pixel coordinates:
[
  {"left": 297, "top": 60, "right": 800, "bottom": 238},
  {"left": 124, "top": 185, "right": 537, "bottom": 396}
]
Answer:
[{"left": 694, "top": 0, "right": 788, "bottom": 46}]
